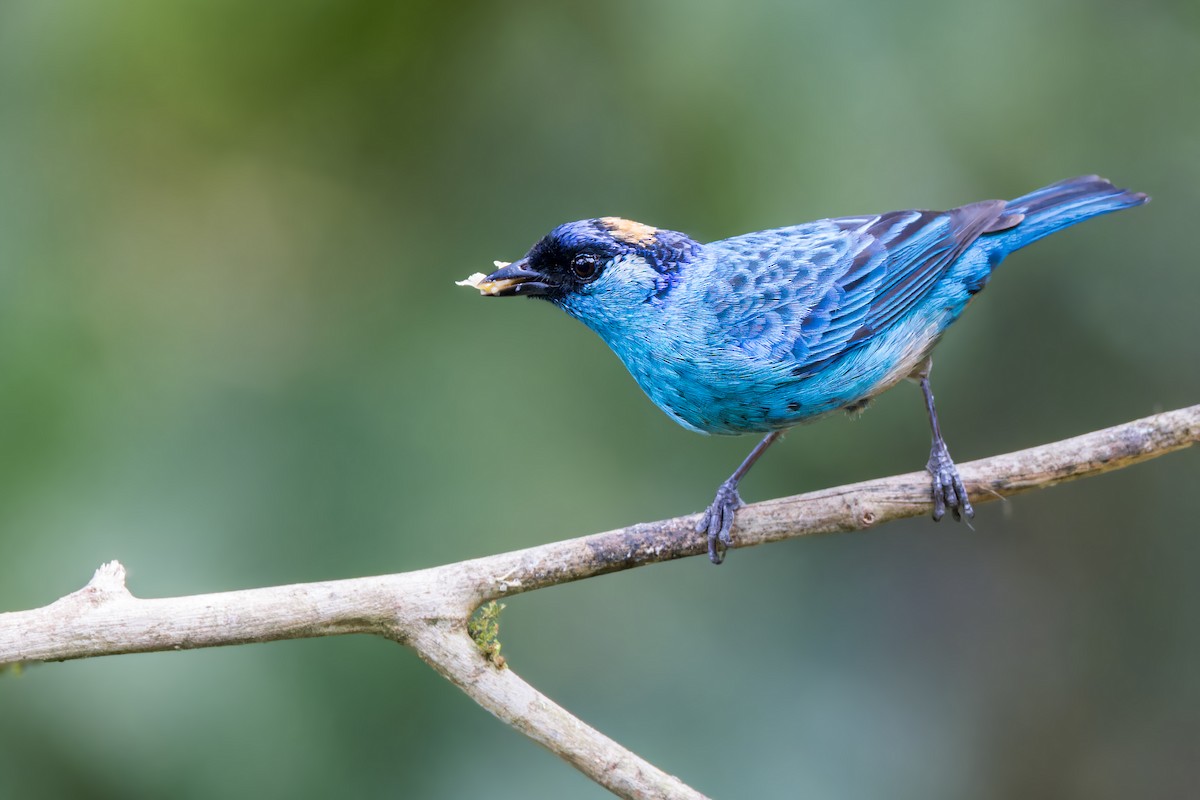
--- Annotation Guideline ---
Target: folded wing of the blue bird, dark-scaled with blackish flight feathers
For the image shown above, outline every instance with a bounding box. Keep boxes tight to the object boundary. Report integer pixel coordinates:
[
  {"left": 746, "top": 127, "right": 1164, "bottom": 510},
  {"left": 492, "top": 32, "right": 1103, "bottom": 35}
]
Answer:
[{"left": 708, "top": 200, "right": 1020, "bottom": 375}]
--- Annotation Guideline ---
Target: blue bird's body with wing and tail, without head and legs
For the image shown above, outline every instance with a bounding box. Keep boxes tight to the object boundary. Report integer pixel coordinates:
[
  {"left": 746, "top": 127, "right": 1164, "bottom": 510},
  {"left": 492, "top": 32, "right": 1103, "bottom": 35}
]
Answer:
[{"left": 614, "top": 176, "right": 1145, "bottom": 433}]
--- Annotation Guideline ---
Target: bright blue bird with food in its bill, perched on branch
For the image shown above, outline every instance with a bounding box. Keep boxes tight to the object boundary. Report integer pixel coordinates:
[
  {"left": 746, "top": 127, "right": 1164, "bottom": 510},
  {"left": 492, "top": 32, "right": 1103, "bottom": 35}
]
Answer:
[{"left": 460, "top": 175, "right": 1150, "bottom": 564}]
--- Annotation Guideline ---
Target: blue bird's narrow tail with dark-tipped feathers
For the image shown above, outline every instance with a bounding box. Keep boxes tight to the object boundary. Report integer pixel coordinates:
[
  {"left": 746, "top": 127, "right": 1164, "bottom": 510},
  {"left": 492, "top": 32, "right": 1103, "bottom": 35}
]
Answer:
[{"left": 1000, "top": 175, "right": 1150, "bottom": 252}]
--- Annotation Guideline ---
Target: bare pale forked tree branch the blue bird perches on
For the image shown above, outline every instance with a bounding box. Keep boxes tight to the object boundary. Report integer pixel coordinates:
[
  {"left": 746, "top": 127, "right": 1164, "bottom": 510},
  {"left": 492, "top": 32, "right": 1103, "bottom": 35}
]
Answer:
[{"left": 0, "top": 405, "right": 1200, "bottom": 798}]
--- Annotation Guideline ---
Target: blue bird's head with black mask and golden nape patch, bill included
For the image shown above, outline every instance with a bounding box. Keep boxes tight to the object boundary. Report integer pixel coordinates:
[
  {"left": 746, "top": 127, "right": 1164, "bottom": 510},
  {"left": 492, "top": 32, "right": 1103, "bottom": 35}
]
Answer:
[{"left": 473, "top": 217, "right": 700, "bottom": 327}]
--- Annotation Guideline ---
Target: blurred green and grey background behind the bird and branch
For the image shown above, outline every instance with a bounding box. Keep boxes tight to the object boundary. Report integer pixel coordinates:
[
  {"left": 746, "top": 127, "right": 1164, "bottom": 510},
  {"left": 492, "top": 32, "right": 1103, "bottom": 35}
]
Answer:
[{"left": 0, "top": 0, "right": 1200, "bottom": 800}]
